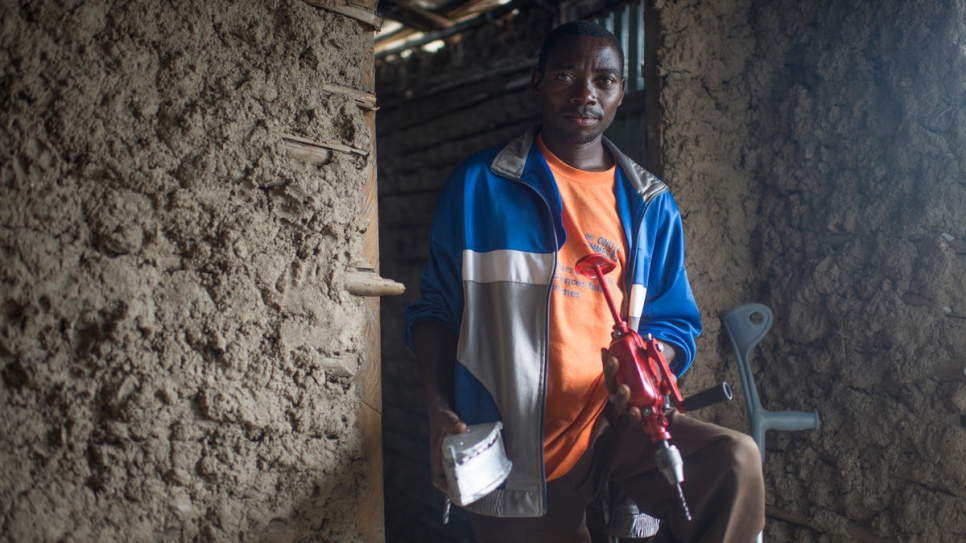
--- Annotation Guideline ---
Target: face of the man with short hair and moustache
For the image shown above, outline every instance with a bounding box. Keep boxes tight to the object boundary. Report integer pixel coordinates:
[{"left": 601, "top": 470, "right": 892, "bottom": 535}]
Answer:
[{"left": 532, "top": 36, "right": 624, "bottom": 144}]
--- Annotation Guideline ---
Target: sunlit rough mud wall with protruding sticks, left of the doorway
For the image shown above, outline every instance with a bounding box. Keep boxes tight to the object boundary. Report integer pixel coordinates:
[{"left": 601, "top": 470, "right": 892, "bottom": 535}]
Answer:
[{"left": 0, "top": 0, "right": 372, "bottom": 542}]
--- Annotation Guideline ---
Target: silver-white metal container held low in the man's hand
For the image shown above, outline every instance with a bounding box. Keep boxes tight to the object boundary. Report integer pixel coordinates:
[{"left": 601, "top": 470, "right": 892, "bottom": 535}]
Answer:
[{"left": 443, "top": 422, "right": 513, "bottom": 507}]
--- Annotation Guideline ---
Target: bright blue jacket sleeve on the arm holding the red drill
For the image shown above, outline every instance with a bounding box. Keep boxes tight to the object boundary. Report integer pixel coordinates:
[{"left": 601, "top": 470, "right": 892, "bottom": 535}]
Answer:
[{"left": 638, "top": 192, "right": 701, "bottom": 377}]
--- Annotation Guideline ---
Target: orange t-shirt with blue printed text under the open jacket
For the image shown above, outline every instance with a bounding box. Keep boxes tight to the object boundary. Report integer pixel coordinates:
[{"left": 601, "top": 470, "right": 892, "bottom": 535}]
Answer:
[{"left": 537, "top": 137, "right": 627, "bottom": 480}]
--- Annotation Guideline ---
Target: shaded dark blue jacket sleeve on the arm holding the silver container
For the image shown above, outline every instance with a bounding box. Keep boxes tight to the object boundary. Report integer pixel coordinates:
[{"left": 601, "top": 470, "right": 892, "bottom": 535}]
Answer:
[{"left": 403, "top": 167, "right": 465, "bottom": 349}]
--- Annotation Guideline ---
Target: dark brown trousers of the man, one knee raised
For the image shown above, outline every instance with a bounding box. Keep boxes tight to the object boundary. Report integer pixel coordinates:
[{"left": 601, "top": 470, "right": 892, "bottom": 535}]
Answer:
[{"left": 469, "top": 412, "right": 765, "bottom": 543}]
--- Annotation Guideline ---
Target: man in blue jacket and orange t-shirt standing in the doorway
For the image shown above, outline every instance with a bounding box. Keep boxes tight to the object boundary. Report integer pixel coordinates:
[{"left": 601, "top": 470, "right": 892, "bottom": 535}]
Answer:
[{"left": 405, "top": 22, "right": 764, "bottom": 543}]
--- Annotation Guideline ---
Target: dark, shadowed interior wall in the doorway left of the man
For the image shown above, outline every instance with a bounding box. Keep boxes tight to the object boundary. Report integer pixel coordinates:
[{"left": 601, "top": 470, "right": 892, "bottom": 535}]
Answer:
[{"left": 376, "top": 5, "right": 551, "bottom": 543}]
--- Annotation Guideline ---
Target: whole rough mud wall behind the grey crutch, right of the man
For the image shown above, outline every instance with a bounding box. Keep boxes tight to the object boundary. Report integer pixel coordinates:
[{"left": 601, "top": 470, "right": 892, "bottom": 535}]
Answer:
[{"left": 659, "top": 1, "right": 966, "bottom": 542}]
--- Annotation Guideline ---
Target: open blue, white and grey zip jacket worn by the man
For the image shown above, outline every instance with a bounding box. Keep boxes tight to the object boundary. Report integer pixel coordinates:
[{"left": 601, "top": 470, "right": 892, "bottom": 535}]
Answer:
[{"left": 404, "top": 130, "right": 701, "bottom": 517}]
